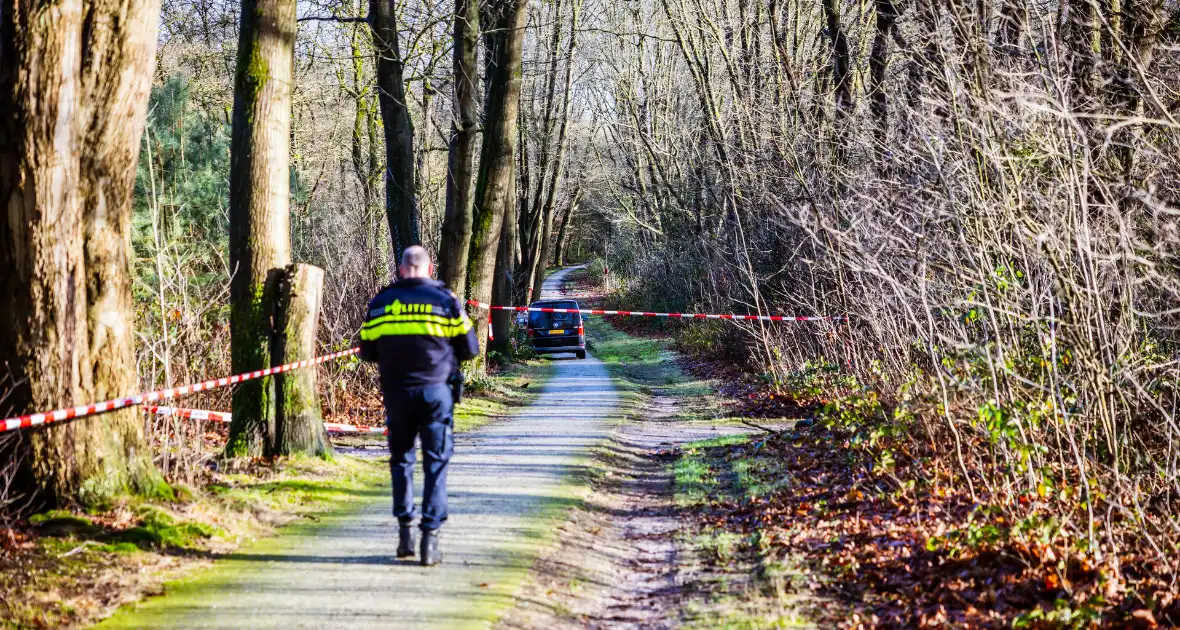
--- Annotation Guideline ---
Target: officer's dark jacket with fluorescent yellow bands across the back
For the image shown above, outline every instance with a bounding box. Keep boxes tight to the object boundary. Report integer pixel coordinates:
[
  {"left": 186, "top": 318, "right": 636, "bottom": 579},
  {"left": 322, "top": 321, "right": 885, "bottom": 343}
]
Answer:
[{"left": 360, "top": 278, "right": 479, "bottom": 392}]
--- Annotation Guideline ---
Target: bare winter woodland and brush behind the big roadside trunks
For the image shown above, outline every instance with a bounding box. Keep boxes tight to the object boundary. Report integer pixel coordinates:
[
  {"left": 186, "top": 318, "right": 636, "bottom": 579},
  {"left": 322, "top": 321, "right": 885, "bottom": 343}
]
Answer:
[{"left": 2, "top": 0, "right": 1180, "bottom": 622}]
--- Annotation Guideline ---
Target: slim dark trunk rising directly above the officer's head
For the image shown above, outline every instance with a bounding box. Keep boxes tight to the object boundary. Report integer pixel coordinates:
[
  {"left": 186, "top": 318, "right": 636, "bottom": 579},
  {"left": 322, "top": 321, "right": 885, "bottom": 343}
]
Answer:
[{"left": 369, "top": 0, "right": 421, "bottom": 261}]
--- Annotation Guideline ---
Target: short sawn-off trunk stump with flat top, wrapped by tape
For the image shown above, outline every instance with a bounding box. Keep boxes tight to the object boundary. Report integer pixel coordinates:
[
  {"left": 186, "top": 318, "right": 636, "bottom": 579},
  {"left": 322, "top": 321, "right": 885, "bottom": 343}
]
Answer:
[{"left": 271, "top": 264, "right": 332, "bottom": 455}]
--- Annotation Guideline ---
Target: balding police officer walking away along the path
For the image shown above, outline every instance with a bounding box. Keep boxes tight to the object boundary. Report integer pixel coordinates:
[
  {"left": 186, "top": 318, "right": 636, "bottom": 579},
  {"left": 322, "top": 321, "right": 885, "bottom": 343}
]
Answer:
[{"left": 360, "top": 245, "right": 479, "bottom": 566}]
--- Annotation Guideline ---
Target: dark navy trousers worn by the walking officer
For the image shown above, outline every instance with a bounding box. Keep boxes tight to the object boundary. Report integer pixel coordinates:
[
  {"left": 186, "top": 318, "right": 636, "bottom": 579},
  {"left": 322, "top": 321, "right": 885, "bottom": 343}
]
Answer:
[{"left": 385, "top": 383, "right": 454, "bottom": 530}]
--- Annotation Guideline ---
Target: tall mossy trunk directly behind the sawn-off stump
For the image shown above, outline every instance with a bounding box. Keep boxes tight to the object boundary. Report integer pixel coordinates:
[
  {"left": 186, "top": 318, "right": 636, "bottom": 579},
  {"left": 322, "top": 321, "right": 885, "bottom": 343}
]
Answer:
[{"left": 225, "top": 0, "right": 296, "bottom": 457}]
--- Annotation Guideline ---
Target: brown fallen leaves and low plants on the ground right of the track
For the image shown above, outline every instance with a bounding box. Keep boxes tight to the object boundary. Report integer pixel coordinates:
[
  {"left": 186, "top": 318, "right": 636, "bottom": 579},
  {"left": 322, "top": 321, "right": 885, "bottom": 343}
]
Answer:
[{"left": 571, "top": 261, "right": 1180, "bottom": 628}]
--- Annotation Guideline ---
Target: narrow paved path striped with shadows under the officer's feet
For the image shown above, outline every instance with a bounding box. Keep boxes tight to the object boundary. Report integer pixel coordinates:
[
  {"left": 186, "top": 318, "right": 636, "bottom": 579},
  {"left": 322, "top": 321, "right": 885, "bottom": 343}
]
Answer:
[{"left": 100, "top": 268, "right": 620, "bottom": 629}]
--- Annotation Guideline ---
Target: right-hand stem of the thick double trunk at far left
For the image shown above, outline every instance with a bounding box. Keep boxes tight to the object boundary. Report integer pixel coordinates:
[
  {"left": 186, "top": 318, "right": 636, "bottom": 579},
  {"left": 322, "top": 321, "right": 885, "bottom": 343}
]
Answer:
[{"left": 76, "top": 0, "right": 163, "bottom": 503}]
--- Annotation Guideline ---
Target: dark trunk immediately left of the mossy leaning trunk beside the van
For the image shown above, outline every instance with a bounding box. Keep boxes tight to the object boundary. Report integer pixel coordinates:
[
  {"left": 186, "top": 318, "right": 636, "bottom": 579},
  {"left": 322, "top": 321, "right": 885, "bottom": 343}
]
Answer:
[{"left": 439, "top": 0, "right": 479, "bottom": 294}]
